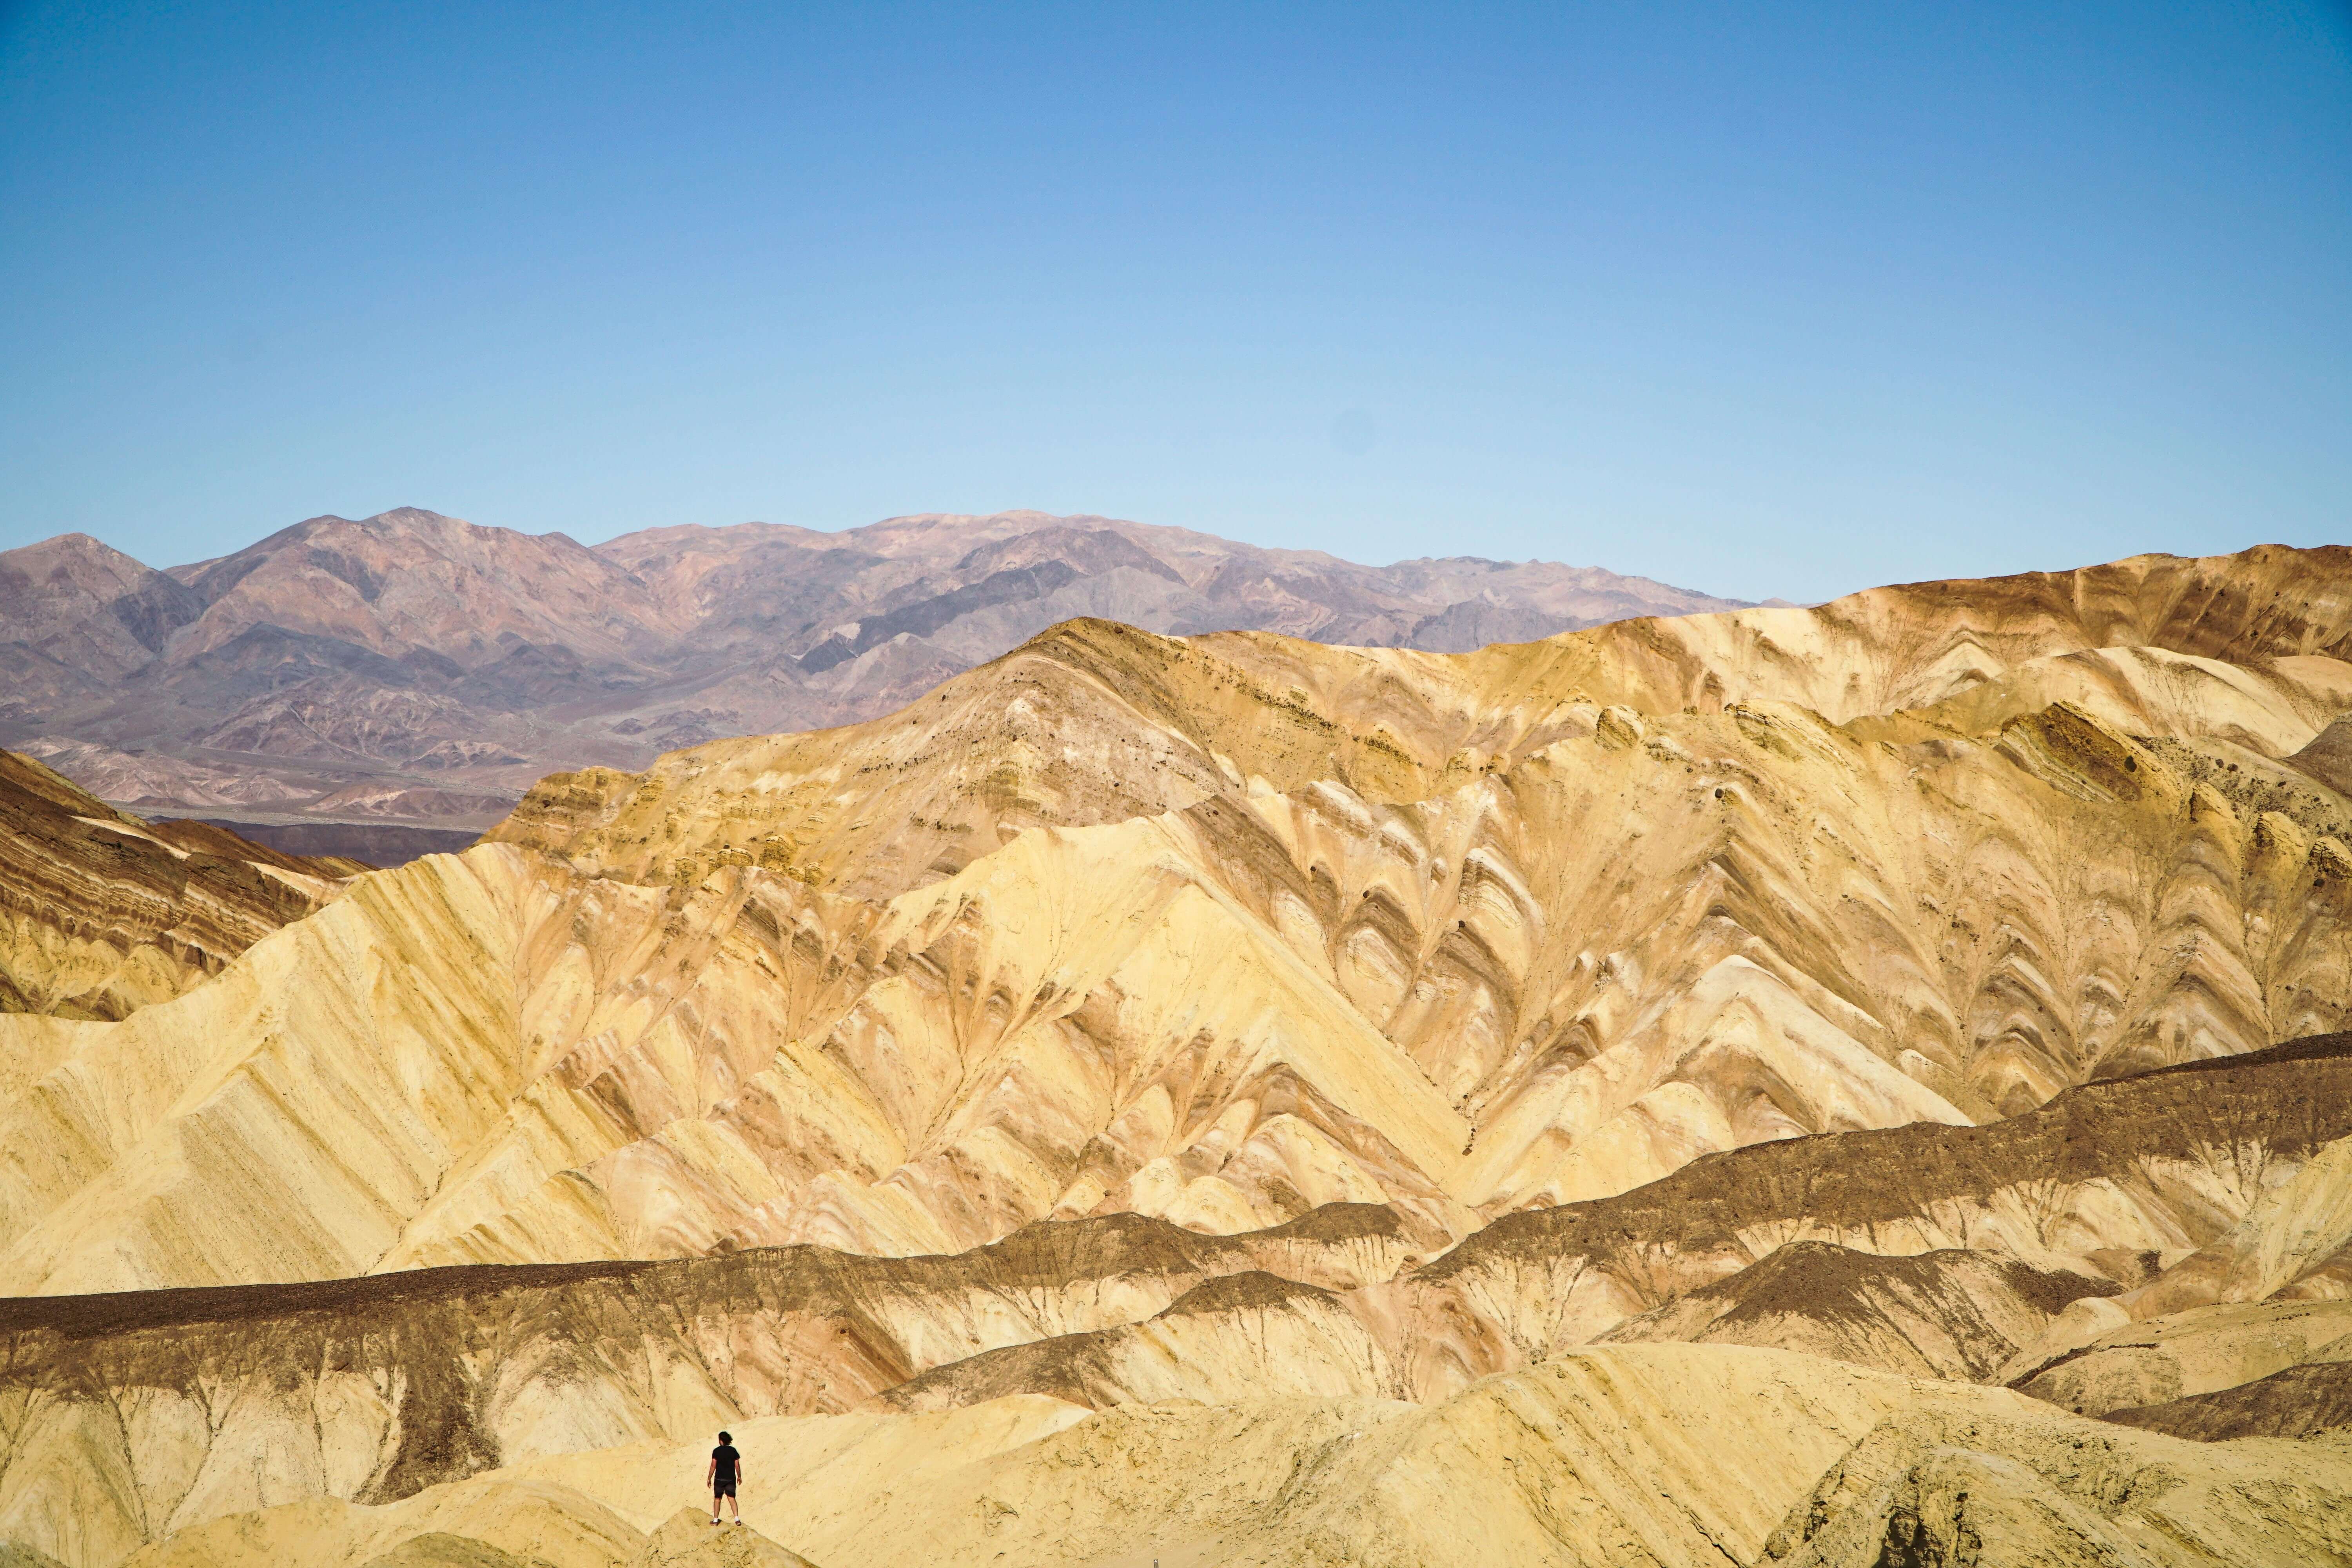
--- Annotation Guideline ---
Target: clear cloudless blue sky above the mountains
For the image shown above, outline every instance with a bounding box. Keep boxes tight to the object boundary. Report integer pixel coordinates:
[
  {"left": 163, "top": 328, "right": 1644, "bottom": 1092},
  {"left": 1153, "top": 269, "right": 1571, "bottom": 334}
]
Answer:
[{"left": 0, "top": 0, "right": 2352, "bottom": 599}]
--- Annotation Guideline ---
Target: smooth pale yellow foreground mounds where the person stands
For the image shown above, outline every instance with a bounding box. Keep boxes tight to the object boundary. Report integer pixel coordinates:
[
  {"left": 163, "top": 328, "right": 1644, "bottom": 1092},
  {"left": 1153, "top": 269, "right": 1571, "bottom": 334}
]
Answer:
[{"left": 101, "top": 1345, "right": 2352, "bottom": 1568}]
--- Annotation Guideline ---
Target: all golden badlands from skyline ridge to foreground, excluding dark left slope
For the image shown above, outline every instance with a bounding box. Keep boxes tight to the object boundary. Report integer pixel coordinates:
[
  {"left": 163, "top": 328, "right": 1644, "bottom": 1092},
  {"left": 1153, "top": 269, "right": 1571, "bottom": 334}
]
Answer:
[{"left": 0, "top": 550, "right": 2352, "bottom": 1568}]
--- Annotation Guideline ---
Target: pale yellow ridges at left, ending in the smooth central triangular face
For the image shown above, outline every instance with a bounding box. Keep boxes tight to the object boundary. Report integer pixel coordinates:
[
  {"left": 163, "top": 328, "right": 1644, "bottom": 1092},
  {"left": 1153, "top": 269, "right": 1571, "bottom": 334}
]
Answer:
[{"left": 0, "top": 823, "right": 1475, "bottom": 1293}]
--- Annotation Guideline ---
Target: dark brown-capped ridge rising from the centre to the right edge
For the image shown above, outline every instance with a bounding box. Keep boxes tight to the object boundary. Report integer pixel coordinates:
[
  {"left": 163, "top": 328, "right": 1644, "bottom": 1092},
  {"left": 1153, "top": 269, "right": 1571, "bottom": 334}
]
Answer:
[{"left": 1374, "top": 1034, "right": 2352, "bottom": 1396}]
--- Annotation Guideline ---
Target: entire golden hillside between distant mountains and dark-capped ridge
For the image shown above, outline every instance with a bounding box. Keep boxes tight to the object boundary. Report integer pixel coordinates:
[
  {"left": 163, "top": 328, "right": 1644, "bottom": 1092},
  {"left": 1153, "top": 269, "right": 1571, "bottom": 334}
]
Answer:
[{"left": 14, "top": 550, "right": 2352, "bottom": 1295}]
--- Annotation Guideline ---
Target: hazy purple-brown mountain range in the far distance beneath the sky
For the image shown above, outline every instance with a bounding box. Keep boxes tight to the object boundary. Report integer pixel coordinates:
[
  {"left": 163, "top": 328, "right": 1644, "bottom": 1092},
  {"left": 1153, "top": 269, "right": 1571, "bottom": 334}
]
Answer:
[{"left": 0, "top": 508, "right": 1743, "bottom": 828}]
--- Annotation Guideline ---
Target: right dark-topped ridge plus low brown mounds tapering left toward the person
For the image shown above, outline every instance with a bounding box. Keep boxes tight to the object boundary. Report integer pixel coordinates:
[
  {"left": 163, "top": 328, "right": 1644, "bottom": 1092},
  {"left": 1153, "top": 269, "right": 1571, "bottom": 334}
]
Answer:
[{"left": 856, "top": 1037, "right": 2352, "bottom": 1415}]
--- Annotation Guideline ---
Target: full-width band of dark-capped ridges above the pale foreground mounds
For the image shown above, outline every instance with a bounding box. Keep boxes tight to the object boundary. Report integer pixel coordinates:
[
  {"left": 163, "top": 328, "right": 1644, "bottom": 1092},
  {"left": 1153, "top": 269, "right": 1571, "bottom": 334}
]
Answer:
[{"left": 0, "top": 1037, "right": 2352, "bottom": 1549}]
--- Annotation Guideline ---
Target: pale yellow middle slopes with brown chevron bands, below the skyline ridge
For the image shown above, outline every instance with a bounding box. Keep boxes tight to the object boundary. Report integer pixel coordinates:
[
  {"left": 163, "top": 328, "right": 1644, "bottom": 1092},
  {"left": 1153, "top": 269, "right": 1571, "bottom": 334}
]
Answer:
[{"left": 18, "top": 686, "right": 2352, "bottom": 1290}]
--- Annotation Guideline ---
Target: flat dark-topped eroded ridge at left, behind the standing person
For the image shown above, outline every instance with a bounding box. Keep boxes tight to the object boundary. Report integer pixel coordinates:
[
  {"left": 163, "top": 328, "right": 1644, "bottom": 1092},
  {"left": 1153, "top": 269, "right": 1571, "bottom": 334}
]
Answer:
[{"left": 0, "top": 1208, "right": 1409, "bottom": 1561}]
